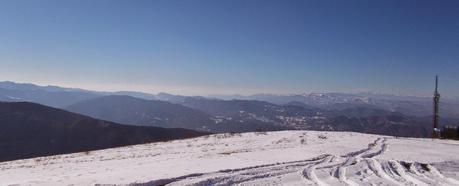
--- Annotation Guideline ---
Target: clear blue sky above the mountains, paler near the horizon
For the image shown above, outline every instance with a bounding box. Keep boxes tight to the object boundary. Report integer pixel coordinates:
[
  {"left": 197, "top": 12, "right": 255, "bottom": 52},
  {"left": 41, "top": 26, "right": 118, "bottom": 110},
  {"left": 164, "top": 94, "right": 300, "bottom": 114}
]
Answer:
[{"left": 0, "top": 0, "right": 459, "bottom": 96}]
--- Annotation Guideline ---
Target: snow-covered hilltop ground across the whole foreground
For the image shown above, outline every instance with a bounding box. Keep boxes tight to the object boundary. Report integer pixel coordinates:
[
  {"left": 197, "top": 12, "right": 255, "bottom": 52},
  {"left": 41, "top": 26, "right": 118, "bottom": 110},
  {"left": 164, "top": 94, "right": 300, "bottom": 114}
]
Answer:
[{"left": 0, "top": 131, "right": 459, "bottom": 185}]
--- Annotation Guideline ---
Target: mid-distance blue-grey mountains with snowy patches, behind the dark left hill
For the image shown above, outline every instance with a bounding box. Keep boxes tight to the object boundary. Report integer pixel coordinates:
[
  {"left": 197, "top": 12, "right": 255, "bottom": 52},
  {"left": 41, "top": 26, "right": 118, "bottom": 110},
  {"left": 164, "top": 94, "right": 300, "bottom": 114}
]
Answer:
[{"left": 66, "top": 96, "right": 430, "bottom": 137}]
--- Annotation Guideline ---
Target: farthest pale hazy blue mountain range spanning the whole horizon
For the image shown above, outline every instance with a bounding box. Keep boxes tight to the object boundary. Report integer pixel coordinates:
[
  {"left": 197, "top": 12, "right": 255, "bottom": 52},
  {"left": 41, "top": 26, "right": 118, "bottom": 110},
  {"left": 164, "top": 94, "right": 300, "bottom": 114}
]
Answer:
[{"left": 0, "top": 81, "right": 459, "bottom": 119}]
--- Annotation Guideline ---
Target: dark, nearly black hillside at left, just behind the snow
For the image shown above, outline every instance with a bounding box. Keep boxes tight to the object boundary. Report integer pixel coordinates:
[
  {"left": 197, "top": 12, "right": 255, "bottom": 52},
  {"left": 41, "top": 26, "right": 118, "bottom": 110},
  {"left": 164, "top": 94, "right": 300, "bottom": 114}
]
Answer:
[{"left": 0, "top": 102, "right": 207, "bottom": 161}]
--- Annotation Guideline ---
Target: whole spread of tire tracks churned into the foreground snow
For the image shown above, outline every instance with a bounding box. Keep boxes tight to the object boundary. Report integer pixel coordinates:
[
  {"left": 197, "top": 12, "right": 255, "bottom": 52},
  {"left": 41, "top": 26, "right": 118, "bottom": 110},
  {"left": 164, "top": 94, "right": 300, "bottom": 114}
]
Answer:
[{"left": 128, "top": 137, "right": 459, "bottom": 186}]
